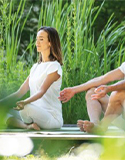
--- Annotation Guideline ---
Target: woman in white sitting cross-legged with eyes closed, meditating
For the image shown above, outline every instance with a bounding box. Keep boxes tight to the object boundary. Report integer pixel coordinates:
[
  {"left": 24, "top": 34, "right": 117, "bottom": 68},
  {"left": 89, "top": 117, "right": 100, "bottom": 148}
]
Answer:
[{"left": 1, "top": 27, "right": 63, "bottom": 130}]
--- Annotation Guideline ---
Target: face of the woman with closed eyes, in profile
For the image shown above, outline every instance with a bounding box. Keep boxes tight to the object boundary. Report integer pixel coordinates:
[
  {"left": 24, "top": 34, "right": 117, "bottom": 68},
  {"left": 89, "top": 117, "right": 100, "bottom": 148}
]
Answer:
[{"left": 36, "top": 30, "right": 50, "bottom": 52}]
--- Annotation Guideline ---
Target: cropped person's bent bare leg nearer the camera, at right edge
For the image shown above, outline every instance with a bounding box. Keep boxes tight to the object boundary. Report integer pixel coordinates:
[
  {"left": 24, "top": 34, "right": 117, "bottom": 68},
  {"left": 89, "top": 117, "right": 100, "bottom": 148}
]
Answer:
[{"left": 78, "top": 91, "right": 125, "bottom": 132}]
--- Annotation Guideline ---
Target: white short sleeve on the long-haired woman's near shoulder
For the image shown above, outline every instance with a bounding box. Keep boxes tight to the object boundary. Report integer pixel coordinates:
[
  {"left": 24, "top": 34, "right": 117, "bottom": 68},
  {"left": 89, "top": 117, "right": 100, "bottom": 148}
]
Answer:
[{"left": 47, "top": 62, "right": 62, "bottom": 77}]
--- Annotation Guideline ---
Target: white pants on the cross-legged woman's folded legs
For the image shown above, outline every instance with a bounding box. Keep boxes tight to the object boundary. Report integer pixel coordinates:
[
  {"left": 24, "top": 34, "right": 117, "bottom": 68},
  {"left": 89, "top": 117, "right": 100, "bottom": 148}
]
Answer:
[{"left": 6, "top": 104, "right": 63, "bottom": 129}]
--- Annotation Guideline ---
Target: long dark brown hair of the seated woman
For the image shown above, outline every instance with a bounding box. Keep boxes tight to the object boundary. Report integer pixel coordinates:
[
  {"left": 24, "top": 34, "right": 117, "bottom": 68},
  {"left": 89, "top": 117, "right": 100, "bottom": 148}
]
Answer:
[{"left": 38, "top": 26, "right": 63, "bottom": 65}]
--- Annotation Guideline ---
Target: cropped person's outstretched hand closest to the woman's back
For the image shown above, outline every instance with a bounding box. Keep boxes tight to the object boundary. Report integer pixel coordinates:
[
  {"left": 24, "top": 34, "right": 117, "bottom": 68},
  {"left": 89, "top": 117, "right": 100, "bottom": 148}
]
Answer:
[{"left": 59, "top": 88, "right": 75, "bottom": 103}]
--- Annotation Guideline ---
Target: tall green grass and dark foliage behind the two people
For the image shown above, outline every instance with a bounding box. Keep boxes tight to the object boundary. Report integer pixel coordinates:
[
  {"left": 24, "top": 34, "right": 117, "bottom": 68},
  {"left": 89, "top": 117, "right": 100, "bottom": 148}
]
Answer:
[{"left": 0, "top": 0, "right": 125, "bottom": 124}]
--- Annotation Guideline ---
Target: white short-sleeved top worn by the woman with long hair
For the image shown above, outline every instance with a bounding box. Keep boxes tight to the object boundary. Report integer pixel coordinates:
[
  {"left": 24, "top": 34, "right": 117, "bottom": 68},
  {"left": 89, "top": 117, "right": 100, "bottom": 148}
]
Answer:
[{"left": 29, "top": 61, "right": 62, "bottom": 119}]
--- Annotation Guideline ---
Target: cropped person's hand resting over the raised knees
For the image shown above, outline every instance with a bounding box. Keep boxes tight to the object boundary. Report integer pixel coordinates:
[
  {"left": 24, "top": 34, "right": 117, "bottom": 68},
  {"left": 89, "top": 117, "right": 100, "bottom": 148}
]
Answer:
[{"left": 91, "top": 85, "right": 108, "bottom": 100}]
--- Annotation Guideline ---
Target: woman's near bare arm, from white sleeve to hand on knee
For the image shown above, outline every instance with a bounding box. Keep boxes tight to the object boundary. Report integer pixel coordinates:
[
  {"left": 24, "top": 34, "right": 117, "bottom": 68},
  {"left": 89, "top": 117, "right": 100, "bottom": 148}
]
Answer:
[{"left": 15, "top": 71, "right": 60, "bottom": 110}]
